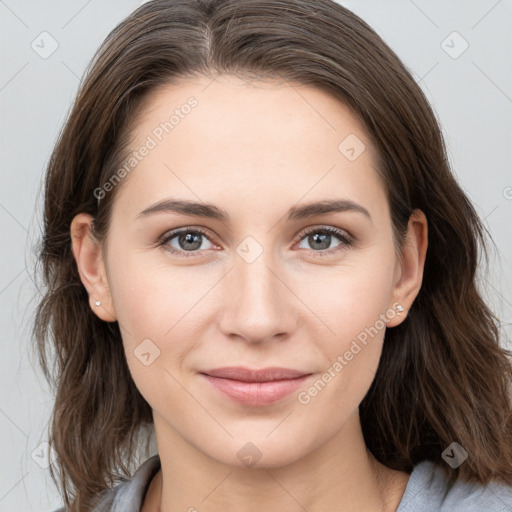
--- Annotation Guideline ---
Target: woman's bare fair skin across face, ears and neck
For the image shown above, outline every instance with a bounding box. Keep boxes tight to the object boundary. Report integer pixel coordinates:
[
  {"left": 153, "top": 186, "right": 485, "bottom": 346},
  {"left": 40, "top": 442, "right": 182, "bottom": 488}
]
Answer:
[{"left": 71, "top": 75, "right": 427, "bottom": 512}]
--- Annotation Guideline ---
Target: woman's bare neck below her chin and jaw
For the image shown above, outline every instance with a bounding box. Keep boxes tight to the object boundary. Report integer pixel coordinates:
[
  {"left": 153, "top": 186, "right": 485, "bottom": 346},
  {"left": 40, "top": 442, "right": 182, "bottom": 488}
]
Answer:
[{"left": 142, "top": 414, "right": 409, "bottom": 512}]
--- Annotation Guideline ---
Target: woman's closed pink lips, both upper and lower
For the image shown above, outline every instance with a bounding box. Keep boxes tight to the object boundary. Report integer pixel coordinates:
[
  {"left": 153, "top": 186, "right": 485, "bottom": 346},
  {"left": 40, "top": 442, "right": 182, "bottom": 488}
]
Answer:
[{"left": 200, "top": 366, "right": 312, "bottom": 406}]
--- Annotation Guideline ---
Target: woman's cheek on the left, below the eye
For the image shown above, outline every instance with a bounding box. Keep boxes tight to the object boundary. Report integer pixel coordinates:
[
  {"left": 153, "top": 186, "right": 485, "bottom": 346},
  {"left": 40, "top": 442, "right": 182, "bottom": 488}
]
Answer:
[{"left": 104, "top": 251, "right": 208, "bottom": 394}]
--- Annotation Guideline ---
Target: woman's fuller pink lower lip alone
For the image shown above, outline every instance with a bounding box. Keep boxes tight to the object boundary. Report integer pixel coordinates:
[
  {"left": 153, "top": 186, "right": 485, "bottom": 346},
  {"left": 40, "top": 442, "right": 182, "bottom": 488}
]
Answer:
[{"left": 201, "top": 374, "right": 310, "bottom": 406}]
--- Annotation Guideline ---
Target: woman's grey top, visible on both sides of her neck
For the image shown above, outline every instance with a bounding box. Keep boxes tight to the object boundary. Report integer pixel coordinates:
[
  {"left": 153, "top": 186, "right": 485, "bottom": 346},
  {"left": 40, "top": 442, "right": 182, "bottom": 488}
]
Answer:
[{"left": 55, "top": 455, "right": 512, "bottom": 512}]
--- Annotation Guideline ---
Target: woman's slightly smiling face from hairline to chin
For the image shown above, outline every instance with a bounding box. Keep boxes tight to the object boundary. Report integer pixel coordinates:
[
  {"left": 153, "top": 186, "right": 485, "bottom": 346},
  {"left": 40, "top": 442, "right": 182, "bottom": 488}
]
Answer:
[{"left": 78, "top": 75, "right": 420, "bottom": 467}]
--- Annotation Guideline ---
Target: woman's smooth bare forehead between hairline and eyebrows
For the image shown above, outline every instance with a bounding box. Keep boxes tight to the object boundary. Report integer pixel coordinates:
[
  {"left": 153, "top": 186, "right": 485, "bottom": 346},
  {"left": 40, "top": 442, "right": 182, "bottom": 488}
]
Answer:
[{"left": 114, "top": 75, "right": 383, "bottom": 214}]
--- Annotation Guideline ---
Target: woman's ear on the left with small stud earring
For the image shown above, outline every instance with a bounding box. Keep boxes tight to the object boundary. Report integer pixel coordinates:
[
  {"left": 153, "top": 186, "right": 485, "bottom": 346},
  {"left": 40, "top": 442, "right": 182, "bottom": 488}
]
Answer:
[{"left": 71, "top": 213, "right": 117, "bottom": 322}]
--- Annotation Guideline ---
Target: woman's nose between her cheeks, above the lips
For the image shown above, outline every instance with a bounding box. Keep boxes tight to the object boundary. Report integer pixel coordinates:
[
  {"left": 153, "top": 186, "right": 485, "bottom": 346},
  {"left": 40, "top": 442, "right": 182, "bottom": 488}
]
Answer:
[{"left": 220, "top": 251, "right": 300, "bottom": 343}]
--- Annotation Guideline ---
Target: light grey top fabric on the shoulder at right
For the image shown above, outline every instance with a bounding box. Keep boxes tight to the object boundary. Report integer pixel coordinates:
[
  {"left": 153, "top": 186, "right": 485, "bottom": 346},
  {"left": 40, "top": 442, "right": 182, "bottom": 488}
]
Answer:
[{"left": 396, "top": 460, "right": 512, "bottom": 512}]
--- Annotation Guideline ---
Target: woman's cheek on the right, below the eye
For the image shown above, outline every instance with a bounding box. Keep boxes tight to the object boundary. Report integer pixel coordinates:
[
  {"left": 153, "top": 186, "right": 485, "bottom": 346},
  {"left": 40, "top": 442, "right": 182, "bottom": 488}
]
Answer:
[{"left": 303, "top": 247, "right": 396, "bottom": 388}]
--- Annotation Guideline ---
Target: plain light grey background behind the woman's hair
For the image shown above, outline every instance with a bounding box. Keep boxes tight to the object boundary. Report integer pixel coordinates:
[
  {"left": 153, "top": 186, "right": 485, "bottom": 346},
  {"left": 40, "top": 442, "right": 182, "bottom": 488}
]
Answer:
[{"left": 0, "top": 0, "right": 512, "bottom": 512}]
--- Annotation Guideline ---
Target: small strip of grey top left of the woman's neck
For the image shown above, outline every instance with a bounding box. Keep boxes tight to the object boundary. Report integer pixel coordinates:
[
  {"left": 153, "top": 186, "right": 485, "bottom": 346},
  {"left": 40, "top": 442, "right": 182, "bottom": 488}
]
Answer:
[{"left": 49, "top": 455, "right": 160, "bottom": 512}]
